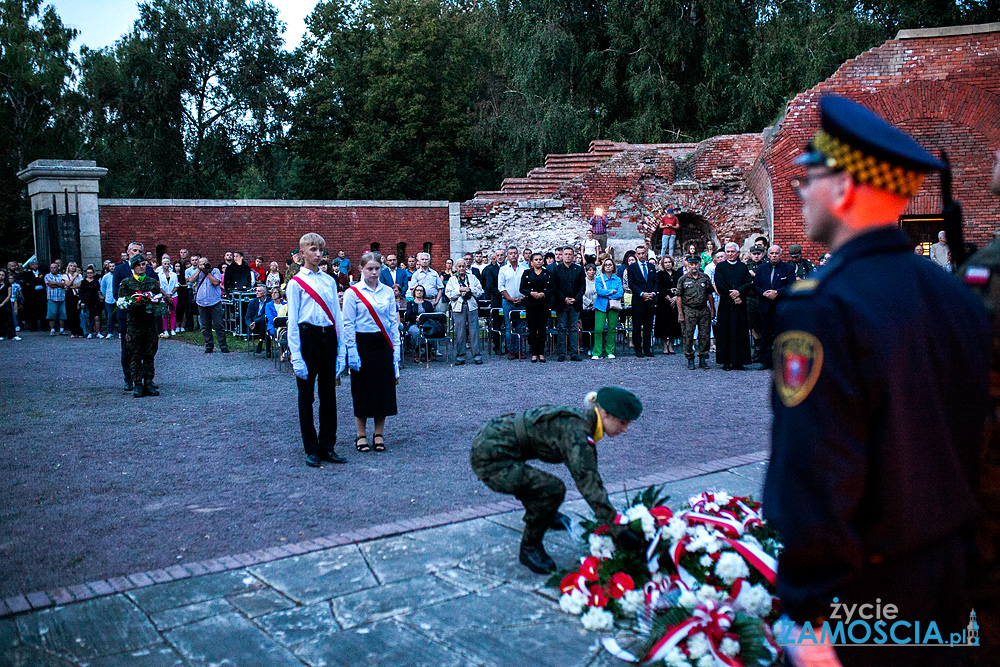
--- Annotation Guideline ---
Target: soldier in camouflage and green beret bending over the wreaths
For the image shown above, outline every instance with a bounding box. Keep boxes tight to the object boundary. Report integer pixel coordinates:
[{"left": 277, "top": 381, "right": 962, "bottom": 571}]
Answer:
[{"left": 469, "top": 387, "right": 642, "bottom": 574}]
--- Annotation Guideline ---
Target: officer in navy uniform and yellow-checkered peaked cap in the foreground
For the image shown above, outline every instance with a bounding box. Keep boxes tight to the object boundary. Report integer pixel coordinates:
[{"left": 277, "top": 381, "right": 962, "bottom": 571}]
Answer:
[{"left": 764, "top": 96, "right": 988, "bottom": 666}]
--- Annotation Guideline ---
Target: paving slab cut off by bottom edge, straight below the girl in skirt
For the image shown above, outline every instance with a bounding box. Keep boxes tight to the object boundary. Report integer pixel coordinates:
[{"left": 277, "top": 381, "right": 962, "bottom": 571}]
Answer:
[{"left": 295, "top": 621, "right": 469, "bottom": 667}]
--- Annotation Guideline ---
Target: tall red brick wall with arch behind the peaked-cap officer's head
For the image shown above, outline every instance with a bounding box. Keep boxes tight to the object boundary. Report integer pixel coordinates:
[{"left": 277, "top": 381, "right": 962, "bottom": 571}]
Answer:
[{"left": 764, "top": 32, "right": 1000, "bottom": 257}]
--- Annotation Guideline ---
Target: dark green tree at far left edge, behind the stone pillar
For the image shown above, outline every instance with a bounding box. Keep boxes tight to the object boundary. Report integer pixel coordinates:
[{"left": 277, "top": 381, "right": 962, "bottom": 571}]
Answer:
[{"left": 0, "top": 0, "right": 76, "bottom": 261}]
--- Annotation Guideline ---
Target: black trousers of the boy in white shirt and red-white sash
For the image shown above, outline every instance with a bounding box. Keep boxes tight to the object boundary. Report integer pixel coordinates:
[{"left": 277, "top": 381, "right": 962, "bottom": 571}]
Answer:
[{"left": 295, "top": 324, "right": 337, "bottom": 456}]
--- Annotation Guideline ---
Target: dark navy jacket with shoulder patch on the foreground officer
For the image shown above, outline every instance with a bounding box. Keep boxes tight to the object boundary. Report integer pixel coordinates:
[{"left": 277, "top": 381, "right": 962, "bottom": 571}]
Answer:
[{"left": 764, "top": 228, "right": 988, "bottom": 622}]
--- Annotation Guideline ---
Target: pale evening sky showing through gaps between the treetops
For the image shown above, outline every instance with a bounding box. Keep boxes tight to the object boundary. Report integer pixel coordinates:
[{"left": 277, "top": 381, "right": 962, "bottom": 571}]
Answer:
[{"left": 43, "top": 0, "right": 319, "bottom": 50}]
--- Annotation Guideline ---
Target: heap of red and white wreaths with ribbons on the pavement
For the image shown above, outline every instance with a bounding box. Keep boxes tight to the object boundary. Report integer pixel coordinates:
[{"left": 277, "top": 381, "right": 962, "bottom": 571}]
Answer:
[{"left": 552, "top": 487, "right": 781, "bottom": 667}]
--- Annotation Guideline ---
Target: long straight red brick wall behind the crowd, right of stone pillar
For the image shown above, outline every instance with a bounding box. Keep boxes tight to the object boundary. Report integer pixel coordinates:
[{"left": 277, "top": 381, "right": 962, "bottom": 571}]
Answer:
[{"left": 100, "top": 200, "right": 450, "bottom": 277}]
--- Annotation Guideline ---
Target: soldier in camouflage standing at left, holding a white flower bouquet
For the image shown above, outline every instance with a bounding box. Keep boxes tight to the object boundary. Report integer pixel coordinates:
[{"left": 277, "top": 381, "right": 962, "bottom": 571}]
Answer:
[{"left": 118, "top": 254, "right": 167, "bottom": 398}]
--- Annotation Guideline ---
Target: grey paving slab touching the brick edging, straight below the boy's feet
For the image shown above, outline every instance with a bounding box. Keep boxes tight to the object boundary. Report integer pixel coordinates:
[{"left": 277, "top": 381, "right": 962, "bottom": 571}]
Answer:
[{"left": 249, "top": 545, "right": 378, "bottom": 604}]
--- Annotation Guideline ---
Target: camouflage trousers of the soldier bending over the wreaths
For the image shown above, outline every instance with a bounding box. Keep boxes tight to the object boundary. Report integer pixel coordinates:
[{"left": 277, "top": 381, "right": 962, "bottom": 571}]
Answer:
[{"left": 469, "top": 423, "right": 566, "bottom": 543}]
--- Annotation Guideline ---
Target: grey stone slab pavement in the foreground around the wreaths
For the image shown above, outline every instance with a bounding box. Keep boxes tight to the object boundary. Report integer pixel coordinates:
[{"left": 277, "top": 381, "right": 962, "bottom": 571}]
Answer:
[{"left": 0, "top": 462, "right": 766, "bottom": 667}]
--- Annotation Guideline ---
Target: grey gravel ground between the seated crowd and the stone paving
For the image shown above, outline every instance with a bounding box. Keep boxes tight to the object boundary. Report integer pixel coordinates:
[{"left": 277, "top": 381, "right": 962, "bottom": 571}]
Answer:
[{"left": 0, "top": 333, "right": 770, "bottom": 596}]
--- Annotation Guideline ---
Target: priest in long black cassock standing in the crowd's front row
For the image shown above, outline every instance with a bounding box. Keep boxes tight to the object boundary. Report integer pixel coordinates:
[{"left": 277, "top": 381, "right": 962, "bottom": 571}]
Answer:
[{"left": 715, "top": 242, "right": 753, "bottom": 371}]
